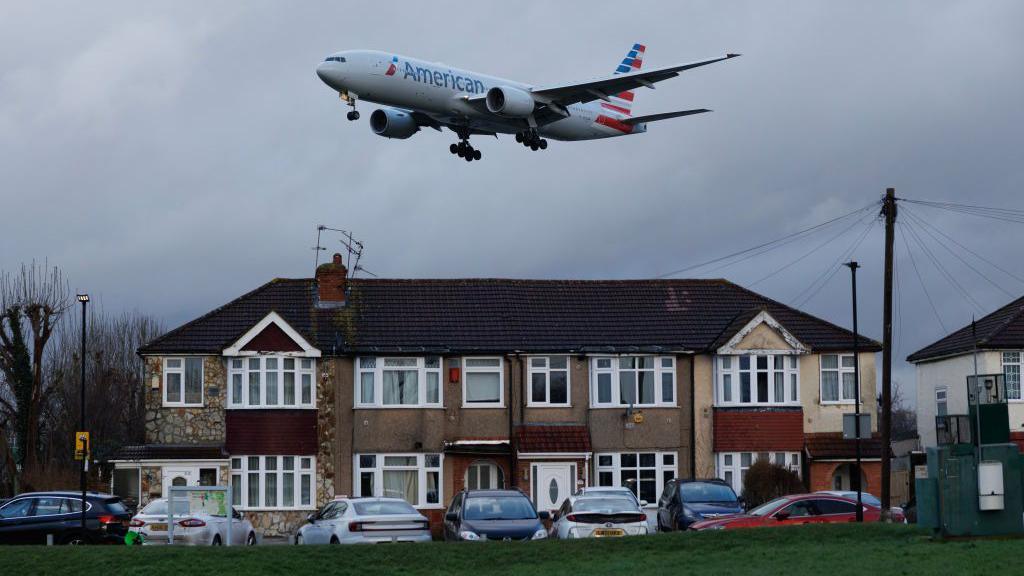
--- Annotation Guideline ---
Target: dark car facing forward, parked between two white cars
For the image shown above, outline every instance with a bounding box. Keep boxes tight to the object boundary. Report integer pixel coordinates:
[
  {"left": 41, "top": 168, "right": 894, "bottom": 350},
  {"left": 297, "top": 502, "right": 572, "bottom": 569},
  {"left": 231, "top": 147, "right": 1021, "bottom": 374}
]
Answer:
[{"left": 444, "top": 490, "right": 550, "bottom": 542}]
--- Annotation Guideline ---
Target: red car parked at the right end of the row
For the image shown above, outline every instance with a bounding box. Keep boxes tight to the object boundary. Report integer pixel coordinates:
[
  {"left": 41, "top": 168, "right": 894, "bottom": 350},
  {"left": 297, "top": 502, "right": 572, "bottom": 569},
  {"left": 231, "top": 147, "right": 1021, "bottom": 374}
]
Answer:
[{"left": 690, "top": 494, "right": 881, "bottom": 530}]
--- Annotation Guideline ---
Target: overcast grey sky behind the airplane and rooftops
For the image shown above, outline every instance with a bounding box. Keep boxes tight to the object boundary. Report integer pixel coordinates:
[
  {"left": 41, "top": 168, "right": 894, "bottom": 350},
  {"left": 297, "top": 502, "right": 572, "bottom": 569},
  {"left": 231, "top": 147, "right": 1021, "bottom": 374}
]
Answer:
[{"left": 0, "top": 0, "right": 1024, "bottom": 403}]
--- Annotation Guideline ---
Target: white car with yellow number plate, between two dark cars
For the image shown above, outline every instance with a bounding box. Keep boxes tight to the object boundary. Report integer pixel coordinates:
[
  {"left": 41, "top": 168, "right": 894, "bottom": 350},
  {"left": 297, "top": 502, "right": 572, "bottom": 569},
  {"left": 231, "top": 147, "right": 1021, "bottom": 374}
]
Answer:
[{"left": 551, "top": 492, "right": 648, "bottom": 539}]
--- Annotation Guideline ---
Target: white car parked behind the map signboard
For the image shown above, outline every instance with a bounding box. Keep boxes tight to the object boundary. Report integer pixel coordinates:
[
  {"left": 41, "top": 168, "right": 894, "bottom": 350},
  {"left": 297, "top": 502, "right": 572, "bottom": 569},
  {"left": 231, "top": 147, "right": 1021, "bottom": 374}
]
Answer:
[{"left": 129, "top": 498, "right": 256, "bottom": 546}]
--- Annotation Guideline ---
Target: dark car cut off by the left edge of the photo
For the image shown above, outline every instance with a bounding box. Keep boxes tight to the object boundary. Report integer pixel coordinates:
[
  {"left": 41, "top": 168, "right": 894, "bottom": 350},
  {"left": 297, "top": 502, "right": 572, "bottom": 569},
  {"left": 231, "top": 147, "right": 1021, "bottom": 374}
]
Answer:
[{"left": 0, "top": 492, "right": 131, "bottom": 544}]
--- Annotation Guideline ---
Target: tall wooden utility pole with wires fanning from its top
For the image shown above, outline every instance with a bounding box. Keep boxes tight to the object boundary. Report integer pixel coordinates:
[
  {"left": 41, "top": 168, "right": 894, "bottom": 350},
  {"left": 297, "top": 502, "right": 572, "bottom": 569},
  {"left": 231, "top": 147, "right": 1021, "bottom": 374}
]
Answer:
[{"left": 879, "top": 188, "right": 896, "bottom": 522}]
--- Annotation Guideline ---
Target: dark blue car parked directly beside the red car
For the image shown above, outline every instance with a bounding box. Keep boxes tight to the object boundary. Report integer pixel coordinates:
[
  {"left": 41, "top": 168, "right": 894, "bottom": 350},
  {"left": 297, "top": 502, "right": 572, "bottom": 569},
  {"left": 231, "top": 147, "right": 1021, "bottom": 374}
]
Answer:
[{"left": 657, "top": 478, "right": 743, "bottom": 532}]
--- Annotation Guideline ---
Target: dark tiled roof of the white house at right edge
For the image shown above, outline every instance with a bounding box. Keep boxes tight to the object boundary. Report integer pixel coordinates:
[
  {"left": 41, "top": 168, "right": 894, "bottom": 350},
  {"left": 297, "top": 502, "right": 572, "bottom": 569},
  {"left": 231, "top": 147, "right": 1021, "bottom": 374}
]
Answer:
[{"left": 906, "top": 297, "right": 1024, "bottom": 362}]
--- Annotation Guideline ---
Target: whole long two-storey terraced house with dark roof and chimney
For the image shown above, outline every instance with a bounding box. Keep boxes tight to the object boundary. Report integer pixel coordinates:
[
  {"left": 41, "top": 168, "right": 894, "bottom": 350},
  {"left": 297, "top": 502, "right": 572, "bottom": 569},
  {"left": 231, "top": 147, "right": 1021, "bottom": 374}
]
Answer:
[{"left": 115, "top": 257, "right": 879, "bottom": 534}]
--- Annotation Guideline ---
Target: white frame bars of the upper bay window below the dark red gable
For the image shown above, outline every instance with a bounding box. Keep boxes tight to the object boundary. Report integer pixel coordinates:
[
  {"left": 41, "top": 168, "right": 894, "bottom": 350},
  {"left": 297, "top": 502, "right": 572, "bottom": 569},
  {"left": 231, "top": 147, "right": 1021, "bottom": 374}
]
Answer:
[{"left": 225, "top": 355, "right": 316, "bottom": 410}]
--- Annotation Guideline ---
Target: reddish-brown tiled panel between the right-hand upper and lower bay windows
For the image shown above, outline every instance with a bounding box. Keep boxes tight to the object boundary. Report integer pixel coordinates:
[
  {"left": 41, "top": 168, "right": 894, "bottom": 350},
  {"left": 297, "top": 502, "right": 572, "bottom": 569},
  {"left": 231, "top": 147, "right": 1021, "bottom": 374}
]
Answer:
[{"left": 714, "top": 408, "right": 804, "bottom": 452}]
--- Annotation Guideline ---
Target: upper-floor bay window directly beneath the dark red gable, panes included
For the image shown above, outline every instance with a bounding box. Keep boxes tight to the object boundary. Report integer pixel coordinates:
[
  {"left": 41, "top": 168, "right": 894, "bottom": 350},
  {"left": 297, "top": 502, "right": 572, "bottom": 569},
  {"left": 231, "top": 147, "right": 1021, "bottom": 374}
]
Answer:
[{"left": 227, "top": 356, "right": 316, "bottom": 408}]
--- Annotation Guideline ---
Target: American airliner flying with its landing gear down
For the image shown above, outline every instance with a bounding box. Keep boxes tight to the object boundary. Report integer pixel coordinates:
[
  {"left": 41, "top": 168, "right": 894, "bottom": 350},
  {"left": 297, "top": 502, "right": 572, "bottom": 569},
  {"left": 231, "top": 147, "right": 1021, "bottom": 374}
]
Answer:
[{"left": 316, "top": 44, "right": 739, "bottom": 162}]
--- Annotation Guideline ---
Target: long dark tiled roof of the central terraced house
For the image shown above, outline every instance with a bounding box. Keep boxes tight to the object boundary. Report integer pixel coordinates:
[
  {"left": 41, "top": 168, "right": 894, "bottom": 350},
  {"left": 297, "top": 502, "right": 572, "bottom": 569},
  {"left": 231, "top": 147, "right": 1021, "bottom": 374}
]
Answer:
[{"left": 140, "top": 279, "right": 880, "bottom": 356}]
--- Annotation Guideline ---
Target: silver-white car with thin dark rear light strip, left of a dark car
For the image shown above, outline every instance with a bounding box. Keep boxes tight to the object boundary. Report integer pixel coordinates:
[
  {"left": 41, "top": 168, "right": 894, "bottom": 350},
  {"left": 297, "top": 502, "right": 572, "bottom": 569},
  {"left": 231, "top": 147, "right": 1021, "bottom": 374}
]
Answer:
[{"left": 294, "top": 498, "right": 432, "bottom": 544}]
